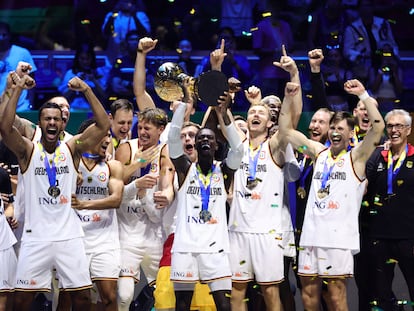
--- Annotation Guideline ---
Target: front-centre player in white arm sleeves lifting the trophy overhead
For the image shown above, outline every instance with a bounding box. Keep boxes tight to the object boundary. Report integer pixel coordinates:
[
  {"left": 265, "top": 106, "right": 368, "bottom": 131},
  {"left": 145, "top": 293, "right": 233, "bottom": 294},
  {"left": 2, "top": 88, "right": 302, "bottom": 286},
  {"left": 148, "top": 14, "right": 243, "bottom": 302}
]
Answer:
[{"left": 168, "top": 93, "right": 243, "bottom": 311}]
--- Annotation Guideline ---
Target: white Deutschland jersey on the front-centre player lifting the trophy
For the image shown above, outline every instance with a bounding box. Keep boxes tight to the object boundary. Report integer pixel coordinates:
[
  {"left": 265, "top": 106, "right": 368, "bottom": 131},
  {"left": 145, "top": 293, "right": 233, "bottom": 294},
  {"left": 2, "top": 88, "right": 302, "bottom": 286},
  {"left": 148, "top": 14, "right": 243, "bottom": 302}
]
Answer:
[{"left": 172, "top": 162, "right": 229, "bottom": 253}]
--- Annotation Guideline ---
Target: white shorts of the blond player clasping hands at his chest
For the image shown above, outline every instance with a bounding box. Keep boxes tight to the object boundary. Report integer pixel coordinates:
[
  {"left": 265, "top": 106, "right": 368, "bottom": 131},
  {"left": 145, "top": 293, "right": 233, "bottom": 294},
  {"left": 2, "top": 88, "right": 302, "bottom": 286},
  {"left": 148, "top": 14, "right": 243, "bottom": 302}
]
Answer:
[{"left": 119, "top": 243, "right": 162, "bottom": 284}]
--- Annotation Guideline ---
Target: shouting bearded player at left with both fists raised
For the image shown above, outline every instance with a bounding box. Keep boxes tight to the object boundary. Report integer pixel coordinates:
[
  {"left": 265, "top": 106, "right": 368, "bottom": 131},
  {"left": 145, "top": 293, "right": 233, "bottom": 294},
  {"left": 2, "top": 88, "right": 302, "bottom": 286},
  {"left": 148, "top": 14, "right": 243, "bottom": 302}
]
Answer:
[{"left": 0, "top": 74, "right": 110, "bottom": 310}]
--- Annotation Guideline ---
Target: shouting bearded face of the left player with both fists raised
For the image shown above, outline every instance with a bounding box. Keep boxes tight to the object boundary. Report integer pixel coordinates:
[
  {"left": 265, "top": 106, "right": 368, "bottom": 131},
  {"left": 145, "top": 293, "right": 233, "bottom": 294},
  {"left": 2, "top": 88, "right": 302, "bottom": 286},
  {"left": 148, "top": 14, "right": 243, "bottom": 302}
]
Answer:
[{"left": 39, "top": 108, "right": 63, "bottom": 148}]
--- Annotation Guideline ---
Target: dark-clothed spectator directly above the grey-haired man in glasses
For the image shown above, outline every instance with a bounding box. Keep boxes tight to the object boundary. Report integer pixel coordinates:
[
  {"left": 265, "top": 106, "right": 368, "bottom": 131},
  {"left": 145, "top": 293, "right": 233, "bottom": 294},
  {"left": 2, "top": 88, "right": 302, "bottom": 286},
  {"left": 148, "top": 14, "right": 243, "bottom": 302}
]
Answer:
[{"left": 371, "top": 43, "right": 403, "bottom": 112}]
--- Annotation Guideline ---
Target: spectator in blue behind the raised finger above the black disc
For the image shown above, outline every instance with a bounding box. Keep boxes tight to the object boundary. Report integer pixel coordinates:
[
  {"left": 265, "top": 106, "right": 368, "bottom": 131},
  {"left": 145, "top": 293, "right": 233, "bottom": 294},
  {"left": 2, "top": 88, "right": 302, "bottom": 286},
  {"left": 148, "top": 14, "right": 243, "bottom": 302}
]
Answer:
[{"left": 194, "top": 27, "right": 253, "bottom": 109}]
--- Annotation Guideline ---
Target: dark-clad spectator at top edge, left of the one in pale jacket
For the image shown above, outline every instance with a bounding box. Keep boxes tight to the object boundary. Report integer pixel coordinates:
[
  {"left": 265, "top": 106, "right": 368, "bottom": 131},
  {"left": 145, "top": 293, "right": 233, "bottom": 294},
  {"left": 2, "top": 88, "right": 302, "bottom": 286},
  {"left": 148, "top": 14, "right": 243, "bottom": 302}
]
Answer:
[{"left": 308, "top": 0, "right": 347, "bottom": 50}]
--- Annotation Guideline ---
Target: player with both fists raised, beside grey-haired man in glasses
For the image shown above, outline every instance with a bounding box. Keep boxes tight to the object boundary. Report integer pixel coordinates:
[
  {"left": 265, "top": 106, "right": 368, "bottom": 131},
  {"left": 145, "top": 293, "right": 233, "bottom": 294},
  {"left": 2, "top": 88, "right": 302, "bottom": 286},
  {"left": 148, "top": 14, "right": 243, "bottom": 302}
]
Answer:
[{"left": 279, "top": 80, "right": 384, "bottom": 310}]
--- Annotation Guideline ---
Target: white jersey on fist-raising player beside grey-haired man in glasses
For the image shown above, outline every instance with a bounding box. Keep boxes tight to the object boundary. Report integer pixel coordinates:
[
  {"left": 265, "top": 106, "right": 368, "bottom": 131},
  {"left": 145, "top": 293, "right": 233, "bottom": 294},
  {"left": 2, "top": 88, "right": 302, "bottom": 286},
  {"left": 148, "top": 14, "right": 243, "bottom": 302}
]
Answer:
[{"left": 299, "top": 149, "right": 366, "bottom": 253}]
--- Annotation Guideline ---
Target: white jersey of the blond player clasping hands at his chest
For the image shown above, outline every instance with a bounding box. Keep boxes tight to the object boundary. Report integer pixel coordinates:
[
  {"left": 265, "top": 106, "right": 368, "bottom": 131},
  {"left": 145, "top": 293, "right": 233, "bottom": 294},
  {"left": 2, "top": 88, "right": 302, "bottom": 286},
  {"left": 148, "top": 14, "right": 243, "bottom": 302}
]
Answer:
[{"left": 117, "top": 139, "right": 163, "bottom": 247}]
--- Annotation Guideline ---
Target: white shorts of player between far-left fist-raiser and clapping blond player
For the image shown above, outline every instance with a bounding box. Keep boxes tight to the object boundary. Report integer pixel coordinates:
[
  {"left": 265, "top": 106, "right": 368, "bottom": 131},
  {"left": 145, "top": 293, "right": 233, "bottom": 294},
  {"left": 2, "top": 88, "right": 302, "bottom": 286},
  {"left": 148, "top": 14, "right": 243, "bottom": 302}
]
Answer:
[{"left": 86, "top": 249, "right": 121, "bottom": 281}]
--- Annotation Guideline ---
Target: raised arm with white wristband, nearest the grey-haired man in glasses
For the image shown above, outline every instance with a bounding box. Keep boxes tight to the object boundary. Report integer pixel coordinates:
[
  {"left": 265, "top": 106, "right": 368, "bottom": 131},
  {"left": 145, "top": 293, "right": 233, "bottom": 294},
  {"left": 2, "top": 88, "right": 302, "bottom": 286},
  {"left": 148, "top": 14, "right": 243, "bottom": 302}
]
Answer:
[{"left": 344, "top": 79, "right": 385, "bottom": 178}]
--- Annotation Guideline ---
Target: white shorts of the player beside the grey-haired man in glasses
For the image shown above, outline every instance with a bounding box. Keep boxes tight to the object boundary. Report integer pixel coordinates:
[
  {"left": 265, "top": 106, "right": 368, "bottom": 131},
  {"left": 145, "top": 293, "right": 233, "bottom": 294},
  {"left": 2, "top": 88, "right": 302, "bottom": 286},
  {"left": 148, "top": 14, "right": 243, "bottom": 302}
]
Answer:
[{"left": 298, "top": 247, "right": 354, "bottom": 278}]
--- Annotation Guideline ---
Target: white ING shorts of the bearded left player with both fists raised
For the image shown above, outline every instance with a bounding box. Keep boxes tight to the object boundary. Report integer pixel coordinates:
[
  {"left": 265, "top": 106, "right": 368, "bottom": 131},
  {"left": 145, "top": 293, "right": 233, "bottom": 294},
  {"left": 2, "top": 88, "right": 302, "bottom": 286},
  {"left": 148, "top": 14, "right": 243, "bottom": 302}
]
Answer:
[{"left": 16, "top": 238, "right": 92, "bottom": 291}]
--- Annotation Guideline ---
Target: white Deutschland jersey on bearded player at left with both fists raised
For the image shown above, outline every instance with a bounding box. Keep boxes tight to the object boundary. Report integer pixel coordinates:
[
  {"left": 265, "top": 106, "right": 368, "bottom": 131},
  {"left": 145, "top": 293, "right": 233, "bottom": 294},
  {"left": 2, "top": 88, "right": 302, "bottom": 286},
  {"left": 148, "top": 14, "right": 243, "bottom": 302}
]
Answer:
[{"left": 21, "top": 143, "right": 83, "bottom": 241}]
